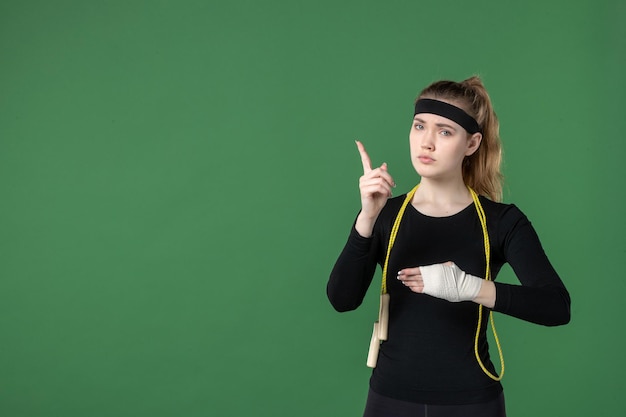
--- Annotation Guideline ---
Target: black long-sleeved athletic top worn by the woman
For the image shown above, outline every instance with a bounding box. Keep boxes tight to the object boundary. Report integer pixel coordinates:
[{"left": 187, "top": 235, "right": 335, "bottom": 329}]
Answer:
[{"left": 327, "top": 195, "right": 570, "bottom": 404}]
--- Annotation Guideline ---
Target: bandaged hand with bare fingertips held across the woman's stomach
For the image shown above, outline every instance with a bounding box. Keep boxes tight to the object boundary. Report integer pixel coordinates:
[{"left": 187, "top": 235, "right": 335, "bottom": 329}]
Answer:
[{"left": 398, "top": 262, "right": 485, "bottom": 302}]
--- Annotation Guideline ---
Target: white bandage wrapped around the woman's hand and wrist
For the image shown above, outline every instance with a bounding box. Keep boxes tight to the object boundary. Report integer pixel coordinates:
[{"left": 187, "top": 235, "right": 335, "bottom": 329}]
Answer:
[{"left": 419, "top": 262, "right": 483, "bottom": 302}]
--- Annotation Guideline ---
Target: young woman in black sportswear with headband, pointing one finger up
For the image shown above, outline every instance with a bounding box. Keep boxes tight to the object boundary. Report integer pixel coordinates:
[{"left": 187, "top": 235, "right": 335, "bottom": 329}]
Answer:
[{"left": 327, "top": 77, "right": 570, "bottom": 417}]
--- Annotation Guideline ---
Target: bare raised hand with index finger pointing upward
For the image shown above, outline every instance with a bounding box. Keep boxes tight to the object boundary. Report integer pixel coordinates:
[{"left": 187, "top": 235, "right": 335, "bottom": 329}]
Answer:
[{"left": 356, "top": 141, "right": 396, "bottom": 220}]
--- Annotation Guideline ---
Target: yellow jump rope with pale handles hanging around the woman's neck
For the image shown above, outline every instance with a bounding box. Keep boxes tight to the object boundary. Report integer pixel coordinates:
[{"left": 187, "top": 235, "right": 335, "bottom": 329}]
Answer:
[{"left": 367, "top": 184, "right": 504, "bottom": 381}]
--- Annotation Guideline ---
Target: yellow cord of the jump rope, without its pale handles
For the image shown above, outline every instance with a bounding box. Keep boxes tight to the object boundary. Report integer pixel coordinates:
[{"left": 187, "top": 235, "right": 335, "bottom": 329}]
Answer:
[{"left": 381, "top": 184, "right": 504, "bottom": 381}]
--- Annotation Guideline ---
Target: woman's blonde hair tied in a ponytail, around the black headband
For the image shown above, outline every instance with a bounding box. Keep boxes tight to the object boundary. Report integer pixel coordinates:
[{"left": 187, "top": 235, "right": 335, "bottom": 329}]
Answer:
[{"left": 416, "top": 76, "right": 503, "bottom": 201}]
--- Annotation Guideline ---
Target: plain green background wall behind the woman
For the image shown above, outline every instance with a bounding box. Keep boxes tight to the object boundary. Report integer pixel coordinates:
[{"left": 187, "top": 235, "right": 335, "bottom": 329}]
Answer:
[{"left": 0, "top": 0, "right": 626, "bottom": 417}]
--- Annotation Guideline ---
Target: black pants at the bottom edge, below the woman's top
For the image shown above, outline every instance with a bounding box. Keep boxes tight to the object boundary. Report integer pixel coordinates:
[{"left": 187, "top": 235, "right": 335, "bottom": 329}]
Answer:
[{"left": 363, "top": 389, "right": 506, "bottom": 417}]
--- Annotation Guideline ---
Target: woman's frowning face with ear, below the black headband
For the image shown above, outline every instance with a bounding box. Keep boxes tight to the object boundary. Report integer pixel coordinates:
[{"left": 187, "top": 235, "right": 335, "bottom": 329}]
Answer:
[{"left": 409, "top": 103, "right": 482, "bottom": 179}]
